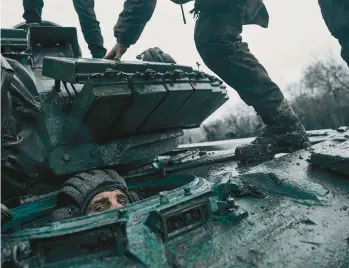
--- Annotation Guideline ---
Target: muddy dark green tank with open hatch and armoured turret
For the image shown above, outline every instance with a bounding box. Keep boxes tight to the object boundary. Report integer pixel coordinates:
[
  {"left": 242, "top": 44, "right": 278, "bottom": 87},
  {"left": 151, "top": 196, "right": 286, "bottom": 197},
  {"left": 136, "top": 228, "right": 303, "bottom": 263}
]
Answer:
[{"left": 1, "top": 24, "right": 349, "bottom": 267}]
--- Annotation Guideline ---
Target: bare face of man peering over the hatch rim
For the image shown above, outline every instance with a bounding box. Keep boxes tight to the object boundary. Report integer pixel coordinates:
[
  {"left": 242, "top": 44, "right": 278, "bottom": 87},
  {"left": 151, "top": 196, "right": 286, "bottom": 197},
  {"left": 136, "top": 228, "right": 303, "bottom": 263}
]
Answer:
[{"left": 86, "top": 190, "right": 130, "bottom": 215}]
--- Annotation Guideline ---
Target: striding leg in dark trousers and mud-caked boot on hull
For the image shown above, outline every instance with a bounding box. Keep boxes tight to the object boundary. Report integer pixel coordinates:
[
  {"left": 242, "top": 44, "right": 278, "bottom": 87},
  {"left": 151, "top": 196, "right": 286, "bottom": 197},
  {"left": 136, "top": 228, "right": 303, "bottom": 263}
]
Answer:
[{"left": 195, "top": 7, "right": 309, "bottom": 161}]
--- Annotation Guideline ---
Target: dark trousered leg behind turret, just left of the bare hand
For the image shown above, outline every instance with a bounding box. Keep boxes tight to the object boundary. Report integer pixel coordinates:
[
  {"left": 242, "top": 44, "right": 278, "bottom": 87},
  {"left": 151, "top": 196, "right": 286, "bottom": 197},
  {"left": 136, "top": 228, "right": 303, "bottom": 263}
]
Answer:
[{"left": 73, "top": 0, "right": 107, "bottom": 58}]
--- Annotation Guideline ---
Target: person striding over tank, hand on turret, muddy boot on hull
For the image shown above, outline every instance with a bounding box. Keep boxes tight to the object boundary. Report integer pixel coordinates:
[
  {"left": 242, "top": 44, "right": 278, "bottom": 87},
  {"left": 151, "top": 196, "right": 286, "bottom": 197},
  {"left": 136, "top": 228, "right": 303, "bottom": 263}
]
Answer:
[{"left": 105, "top": 0, "right": 310, "bottom": 161}]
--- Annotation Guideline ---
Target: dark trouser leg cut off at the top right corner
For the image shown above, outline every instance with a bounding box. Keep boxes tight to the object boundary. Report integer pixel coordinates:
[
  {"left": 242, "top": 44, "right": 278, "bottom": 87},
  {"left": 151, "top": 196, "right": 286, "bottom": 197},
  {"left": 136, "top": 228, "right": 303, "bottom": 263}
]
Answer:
[{"left": 319, "top": 0, "right": 349, "bottom": 66}]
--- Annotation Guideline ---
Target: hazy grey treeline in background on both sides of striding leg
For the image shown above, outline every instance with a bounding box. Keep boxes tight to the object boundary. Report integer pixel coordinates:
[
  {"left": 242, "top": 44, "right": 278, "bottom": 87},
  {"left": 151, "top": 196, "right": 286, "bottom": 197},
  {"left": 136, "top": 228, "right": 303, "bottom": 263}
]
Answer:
[{"left": 181, "top": 53, "right": 349, "bottom": 143}]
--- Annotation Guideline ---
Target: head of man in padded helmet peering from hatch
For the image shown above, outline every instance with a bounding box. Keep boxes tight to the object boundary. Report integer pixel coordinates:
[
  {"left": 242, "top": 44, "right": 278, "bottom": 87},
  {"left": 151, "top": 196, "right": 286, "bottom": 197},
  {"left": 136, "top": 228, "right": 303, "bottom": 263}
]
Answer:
[{"left": 58, "top": 169, "right": 135, "bottom": 216}]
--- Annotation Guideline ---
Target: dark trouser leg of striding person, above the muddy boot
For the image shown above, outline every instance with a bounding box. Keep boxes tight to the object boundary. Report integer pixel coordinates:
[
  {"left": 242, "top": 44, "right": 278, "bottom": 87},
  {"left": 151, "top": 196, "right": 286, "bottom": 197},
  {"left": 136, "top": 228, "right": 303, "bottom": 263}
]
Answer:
[{"left": 195, "top": 8, "right": 284, "bottom": 114}]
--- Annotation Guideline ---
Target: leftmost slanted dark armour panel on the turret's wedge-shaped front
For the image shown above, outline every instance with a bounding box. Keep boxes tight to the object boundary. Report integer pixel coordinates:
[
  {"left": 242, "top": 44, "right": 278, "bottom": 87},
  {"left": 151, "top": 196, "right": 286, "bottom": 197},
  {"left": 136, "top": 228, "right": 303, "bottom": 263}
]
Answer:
[{"left": 64, "top": 72, "right": 132, "bottom": 142}]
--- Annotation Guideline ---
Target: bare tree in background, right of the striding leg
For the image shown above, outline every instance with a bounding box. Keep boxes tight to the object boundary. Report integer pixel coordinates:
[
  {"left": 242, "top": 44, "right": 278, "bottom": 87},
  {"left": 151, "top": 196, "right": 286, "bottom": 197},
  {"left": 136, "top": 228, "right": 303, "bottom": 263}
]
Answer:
[{"left": 289, "top": 56, "right": 349, "bottom": 129}]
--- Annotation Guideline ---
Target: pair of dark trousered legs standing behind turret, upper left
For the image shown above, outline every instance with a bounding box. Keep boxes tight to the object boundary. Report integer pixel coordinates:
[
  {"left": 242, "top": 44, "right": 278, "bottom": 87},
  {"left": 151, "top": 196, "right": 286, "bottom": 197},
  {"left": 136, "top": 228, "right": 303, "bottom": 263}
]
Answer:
[{"left": 23, "top": 0, "right": 107, "bottom": 58}]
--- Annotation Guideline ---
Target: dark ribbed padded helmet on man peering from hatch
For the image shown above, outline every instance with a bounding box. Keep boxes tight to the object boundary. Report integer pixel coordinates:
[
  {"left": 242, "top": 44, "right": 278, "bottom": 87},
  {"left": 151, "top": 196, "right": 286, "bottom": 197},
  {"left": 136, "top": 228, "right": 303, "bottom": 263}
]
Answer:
[{"left": 57, "top": 169, "right": 134, "bottom": 215}]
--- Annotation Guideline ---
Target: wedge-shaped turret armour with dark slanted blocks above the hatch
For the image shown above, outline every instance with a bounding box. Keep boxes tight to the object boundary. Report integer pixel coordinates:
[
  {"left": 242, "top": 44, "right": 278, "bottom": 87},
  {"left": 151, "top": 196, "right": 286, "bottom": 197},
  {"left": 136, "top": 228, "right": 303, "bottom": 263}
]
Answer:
[{"left": 37, "top": 57, "right": 228, "bottom": 175}]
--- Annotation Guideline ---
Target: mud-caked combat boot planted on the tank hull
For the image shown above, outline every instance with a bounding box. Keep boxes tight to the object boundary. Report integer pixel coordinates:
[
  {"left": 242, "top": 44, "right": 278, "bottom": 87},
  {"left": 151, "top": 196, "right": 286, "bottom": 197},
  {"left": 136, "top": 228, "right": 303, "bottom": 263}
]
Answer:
[{"left": 235, "top": 100, "right": 310, "bottom": 162}]
